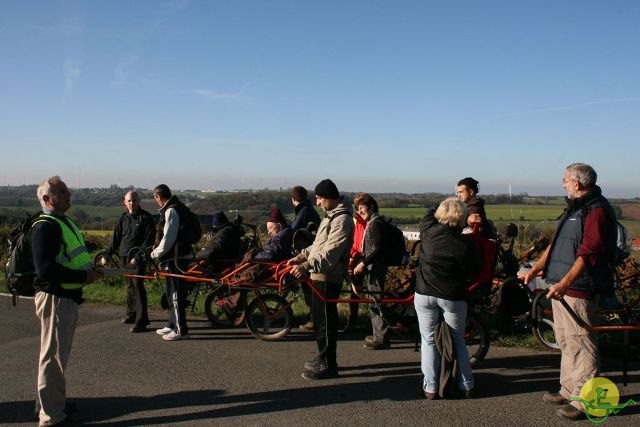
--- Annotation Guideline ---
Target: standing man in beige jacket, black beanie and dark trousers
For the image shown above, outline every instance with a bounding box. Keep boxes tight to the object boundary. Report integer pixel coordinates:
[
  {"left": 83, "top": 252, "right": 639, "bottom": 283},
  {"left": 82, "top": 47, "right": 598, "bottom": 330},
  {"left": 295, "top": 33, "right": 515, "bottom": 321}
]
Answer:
[{"left": 287, "top": 179, "right": 354, "bottom": 380}]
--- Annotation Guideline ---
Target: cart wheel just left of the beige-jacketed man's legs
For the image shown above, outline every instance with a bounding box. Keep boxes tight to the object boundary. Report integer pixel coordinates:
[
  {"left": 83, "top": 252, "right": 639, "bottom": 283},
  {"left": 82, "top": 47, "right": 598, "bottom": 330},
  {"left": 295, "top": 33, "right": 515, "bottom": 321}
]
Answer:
[{"left": 246, "top": 294, "right": 293, "bottom": 341}]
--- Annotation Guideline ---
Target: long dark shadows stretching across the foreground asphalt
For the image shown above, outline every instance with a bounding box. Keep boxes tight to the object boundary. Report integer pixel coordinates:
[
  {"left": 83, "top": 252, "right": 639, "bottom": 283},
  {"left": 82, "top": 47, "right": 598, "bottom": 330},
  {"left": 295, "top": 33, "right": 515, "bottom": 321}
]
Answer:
[{"left": 8, "top": 354, "right": 640, "bottom": 426}]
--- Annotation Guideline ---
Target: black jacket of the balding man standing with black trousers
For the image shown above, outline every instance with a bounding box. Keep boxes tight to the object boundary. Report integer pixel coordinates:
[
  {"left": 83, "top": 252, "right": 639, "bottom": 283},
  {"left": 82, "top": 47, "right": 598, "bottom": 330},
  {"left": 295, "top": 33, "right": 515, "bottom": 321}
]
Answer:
[{"left": 106, "top": 209, "right": 156, "bottom": 261}]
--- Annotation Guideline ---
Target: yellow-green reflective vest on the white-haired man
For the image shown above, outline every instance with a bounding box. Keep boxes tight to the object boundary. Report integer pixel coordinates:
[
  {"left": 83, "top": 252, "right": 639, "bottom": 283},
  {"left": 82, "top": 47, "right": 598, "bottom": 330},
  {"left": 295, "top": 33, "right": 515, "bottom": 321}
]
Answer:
[{"left": 40, "top": 214, "right": 93, "bottom": 290}]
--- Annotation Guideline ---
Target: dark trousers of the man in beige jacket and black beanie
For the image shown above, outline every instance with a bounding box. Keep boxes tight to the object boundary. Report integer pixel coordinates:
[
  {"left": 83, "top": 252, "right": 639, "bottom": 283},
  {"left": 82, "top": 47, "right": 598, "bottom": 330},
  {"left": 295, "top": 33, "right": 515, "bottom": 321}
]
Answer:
[{"left": 311, "top": 280, "right": 342, "bottom": 368}]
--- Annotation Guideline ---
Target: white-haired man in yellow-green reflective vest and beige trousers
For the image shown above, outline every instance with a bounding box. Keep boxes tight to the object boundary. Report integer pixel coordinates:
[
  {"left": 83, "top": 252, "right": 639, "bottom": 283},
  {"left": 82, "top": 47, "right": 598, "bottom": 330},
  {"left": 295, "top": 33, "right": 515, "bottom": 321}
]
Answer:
[{"left": 31, "top": 176, "right": 101, "bottom": 426}]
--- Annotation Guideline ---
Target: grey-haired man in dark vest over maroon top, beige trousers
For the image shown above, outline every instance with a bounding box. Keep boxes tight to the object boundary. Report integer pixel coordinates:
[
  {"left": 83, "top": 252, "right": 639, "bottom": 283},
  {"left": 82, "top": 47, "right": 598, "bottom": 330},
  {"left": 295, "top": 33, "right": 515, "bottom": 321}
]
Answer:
[{"left": 523, "top": 163, "right": 617, "bottom": 420}]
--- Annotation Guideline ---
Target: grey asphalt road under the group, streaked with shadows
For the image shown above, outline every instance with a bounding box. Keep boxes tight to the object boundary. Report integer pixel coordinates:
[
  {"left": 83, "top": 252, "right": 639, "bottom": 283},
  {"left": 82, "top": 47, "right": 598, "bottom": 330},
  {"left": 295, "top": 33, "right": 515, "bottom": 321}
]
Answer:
[{"left": 0, "top": 296, "right": 640, "bottom": 426}]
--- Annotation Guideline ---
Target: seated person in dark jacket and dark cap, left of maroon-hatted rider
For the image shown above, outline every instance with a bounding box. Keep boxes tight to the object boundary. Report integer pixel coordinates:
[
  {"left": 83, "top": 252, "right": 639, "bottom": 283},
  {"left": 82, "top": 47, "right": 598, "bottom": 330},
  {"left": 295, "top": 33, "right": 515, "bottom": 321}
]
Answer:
[{"left": 196, "top": 211, "right": 242, "bottom": 271}]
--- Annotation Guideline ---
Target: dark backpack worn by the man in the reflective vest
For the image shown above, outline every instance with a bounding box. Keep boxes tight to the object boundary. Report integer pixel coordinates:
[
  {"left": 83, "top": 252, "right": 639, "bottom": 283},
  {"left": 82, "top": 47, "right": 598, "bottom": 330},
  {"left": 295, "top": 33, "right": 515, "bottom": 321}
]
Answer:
[{"left": 5, "top": 213, "right": 48, "bottom": 305}]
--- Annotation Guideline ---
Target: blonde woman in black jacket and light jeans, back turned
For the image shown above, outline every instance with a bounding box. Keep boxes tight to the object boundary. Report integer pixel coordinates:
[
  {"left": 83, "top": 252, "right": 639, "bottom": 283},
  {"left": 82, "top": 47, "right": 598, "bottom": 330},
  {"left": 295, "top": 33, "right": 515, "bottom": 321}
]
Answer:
[{"left": 414, "top": 197, "right": 477, "bottom": 399}]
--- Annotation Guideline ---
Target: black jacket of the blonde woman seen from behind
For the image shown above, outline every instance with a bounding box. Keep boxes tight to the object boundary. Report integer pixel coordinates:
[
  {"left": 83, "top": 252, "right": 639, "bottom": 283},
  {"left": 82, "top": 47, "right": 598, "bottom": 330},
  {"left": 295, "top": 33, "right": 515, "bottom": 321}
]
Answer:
[{"left": 416, "top": 209, "right": 478, "bottom": 301}]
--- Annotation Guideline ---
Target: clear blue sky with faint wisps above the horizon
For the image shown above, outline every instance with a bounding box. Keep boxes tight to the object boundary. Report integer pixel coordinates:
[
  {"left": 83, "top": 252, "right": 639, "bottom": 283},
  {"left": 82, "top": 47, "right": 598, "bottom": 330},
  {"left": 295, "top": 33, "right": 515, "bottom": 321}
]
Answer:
[{"left": 0, "top": 0, "right": 640, "bottom": 197}]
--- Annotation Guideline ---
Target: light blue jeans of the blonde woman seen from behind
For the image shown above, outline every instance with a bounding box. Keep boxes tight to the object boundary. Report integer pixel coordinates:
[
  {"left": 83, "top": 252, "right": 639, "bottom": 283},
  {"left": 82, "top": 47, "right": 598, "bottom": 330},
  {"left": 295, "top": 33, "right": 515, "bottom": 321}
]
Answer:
[{"left": 413, "top": 294, "right": 473, "bottom": 393}]
